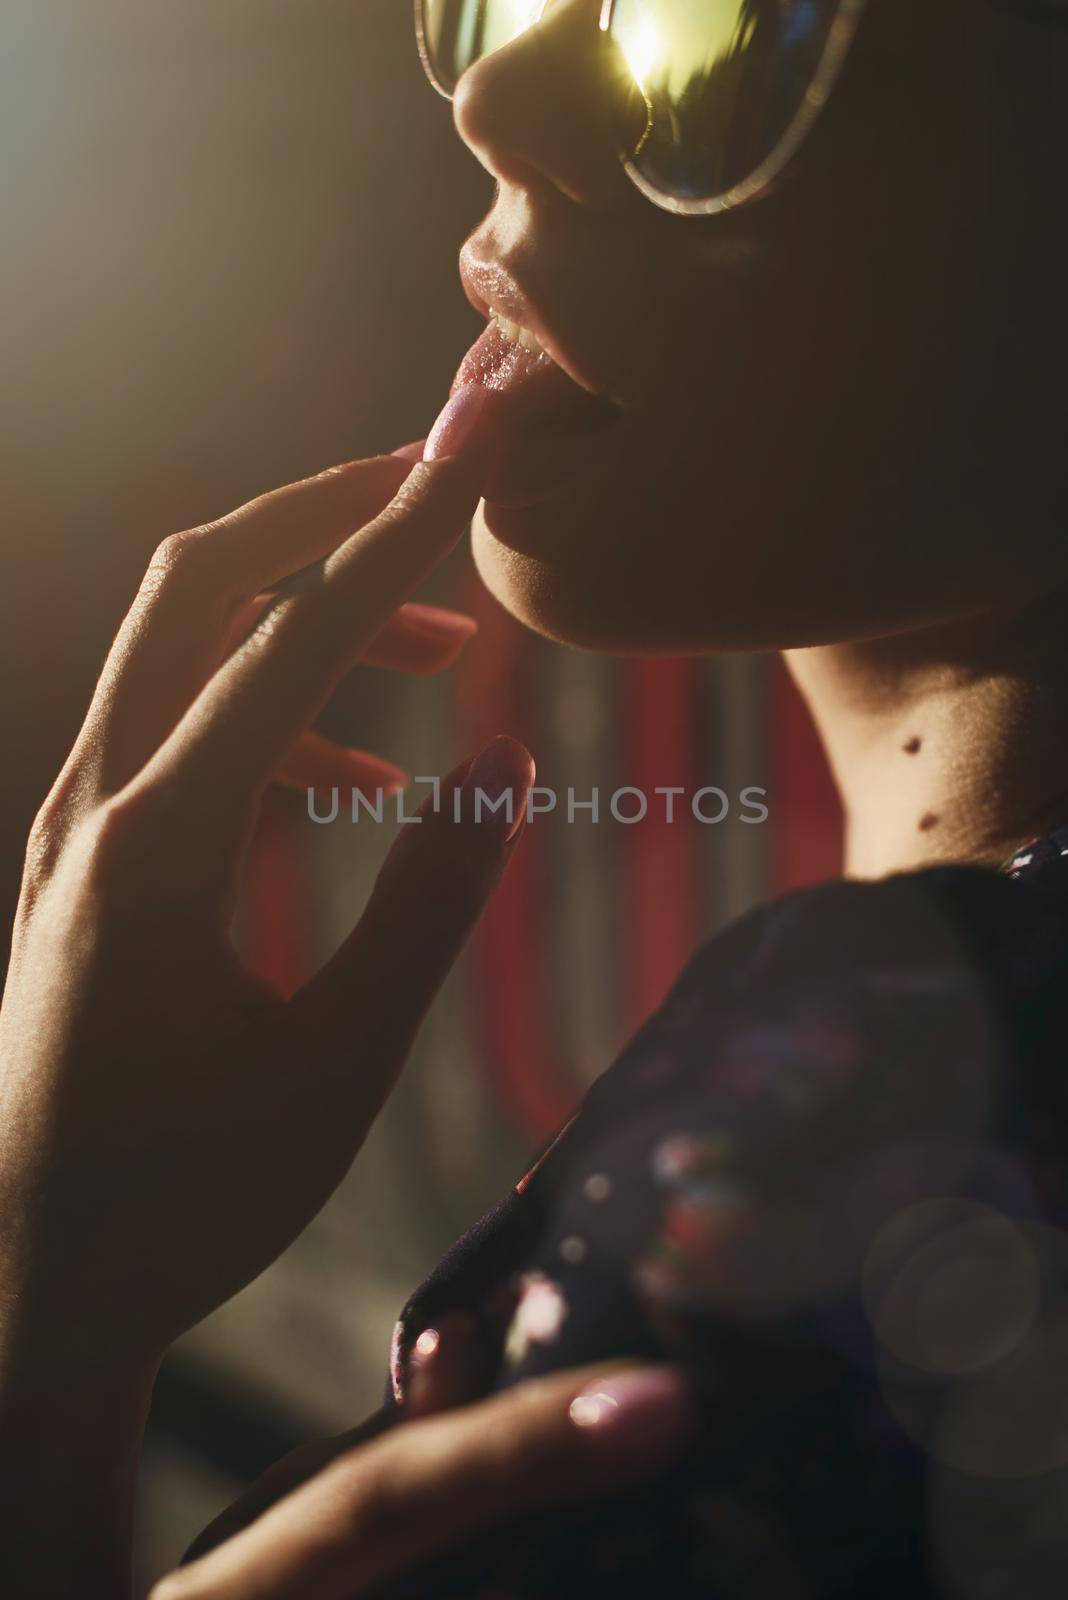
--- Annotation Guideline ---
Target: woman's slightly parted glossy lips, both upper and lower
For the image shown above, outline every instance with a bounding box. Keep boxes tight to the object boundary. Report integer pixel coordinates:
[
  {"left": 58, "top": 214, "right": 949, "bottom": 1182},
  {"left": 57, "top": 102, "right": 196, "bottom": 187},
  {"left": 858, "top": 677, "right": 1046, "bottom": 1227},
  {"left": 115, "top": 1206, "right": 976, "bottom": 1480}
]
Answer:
[{"left": 451, "top": 256, "right": 620, "bottom": 507}]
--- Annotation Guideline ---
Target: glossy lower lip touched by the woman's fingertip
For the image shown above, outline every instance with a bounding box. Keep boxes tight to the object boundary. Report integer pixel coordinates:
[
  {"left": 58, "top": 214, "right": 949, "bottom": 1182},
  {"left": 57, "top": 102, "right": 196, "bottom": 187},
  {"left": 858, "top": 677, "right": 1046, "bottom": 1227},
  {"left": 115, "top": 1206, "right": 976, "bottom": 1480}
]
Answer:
[{"left": 451, "top": 322, "right": 620, "bottom": 509}]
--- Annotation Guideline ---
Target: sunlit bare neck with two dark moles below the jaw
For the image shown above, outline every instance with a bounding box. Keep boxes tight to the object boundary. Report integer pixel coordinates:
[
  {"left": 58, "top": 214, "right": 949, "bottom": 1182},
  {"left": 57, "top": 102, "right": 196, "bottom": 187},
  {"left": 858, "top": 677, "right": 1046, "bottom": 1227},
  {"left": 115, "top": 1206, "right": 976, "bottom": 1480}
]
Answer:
[{"left": 787, "top": 595, "right": 1068, "bottom": 878}]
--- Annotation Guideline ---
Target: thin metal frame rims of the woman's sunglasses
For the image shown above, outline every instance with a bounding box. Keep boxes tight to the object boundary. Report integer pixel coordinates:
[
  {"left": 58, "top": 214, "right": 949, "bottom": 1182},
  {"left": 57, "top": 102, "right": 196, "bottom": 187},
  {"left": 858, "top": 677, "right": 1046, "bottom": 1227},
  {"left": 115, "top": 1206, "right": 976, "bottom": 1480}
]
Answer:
[{"left": 416, "top": 0, "right": 868, "bottom": 216}]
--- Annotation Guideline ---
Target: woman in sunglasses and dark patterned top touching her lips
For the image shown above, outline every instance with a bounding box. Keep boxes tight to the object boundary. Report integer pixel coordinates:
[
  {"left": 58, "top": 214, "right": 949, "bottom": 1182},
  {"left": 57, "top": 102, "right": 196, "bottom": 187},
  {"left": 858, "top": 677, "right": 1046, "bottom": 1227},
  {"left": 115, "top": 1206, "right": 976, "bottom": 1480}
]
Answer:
[{"left": 0, "top": 0, "right": 1068, "bottom": 1600}]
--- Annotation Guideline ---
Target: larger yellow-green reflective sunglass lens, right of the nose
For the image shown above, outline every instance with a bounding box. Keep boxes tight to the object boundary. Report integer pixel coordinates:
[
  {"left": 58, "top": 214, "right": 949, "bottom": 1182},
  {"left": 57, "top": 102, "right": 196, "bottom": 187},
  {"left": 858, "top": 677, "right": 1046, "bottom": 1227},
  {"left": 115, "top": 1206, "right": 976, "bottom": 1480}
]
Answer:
[{"left": 608, "top": 0, "right": 859, "bottom": 208}]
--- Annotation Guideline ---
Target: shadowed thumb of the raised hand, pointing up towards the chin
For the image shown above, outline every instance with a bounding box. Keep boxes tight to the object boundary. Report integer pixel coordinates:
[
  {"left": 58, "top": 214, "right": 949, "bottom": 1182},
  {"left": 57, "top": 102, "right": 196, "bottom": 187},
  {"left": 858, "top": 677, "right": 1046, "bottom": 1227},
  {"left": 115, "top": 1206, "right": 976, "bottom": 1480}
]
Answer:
[{"left": 294, "top": 736, "right": 534, "bottom": 1094}]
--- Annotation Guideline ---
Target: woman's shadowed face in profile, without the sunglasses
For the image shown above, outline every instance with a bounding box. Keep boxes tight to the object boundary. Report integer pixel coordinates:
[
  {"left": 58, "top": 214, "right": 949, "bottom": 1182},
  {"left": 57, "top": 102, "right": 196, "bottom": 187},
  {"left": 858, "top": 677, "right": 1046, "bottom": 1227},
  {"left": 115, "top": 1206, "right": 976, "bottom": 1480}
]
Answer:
[{"left": 438, "top": 0, "right": 1068, "bottom": 651}]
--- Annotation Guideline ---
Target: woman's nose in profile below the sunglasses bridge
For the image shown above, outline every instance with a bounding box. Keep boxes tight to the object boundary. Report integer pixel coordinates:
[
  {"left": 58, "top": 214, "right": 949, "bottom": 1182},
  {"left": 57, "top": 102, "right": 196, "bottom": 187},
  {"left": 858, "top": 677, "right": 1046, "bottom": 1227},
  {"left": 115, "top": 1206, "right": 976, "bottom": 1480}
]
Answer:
[{"left": 454, "top": 0, "right": 638, "bottom": 211}]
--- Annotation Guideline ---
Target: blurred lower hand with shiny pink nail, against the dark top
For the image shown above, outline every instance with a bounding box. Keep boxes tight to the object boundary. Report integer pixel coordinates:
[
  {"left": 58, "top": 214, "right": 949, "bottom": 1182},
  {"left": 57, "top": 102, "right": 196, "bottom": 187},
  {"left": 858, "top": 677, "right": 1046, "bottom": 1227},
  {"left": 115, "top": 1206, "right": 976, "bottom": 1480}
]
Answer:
[{"left": 150, "top": 1366, "right": 689, "bottom": 1600}]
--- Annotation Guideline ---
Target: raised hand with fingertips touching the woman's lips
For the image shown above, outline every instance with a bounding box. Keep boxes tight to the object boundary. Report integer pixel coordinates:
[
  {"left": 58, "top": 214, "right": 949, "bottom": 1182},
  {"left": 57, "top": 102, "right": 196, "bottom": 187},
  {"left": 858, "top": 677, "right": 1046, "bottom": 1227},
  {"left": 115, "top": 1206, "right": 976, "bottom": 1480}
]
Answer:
[{"left": 0, "top": 444, "right": 532, "bottom": 1595}]
